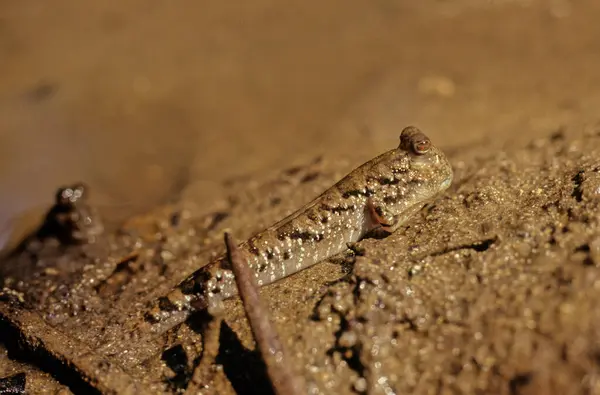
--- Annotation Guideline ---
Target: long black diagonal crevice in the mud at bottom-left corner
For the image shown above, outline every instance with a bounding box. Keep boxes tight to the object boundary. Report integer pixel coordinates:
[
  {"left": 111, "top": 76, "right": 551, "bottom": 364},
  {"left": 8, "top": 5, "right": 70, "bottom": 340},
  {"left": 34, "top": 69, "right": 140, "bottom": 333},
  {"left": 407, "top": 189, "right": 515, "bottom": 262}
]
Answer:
[{"left": 0, "top": 315, "right": 101, "bottom": 395}]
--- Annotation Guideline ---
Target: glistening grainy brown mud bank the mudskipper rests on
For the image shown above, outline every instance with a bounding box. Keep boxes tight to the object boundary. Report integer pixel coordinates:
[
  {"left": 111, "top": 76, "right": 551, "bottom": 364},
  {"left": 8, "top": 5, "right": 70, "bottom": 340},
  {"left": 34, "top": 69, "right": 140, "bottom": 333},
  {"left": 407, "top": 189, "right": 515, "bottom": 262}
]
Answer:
[{"left": 0, "top": 127, "right": 600, "bottom": 394}]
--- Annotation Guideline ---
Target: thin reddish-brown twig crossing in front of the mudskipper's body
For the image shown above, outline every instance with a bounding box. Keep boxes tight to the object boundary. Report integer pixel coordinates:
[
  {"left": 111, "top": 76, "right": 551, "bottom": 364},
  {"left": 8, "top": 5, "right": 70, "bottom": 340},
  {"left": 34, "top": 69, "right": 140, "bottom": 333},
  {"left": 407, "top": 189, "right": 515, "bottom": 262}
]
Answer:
[{"left": 225, "top": 233, "right": 306, "bottom": 395}]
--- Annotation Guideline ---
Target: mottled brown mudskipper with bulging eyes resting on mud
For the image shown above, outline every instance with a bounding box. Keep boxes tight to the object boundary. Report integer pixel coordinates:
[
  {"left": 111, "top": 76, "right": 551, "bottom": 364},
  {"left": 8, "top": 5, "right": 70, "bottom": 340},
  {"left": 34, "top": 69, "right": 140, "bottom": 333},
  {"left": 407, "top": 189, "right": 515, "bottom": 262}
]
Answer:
[{"left": 150, "top": 126, "right": 453, "bottom": 332}]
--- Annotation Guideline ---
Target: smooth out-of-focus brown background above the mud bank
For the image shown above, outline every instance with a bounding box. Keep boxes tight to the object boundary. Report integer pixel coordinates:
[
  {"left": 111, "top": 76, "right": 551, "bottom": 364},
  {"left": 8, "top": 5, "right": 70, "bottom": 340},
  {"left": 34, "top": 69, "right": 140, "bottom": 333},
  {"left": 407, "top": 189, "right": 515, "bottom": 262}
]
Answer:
[{"left": 0, "top": 0, "right": 600, "bottom": 252}]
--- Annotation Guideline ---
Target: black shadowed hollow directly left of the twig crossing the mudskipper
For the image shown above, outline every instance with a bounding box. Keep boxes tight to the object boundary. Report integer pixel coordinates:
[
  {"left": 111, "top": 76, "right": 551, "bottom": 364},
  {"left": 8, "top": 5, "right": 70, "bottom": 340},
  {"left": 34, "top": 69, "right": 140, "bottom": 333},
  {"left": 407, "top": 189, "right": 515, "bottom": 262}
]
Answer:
[{"left": 215, "top": 323, "right": 274, "bottom": 395}]
